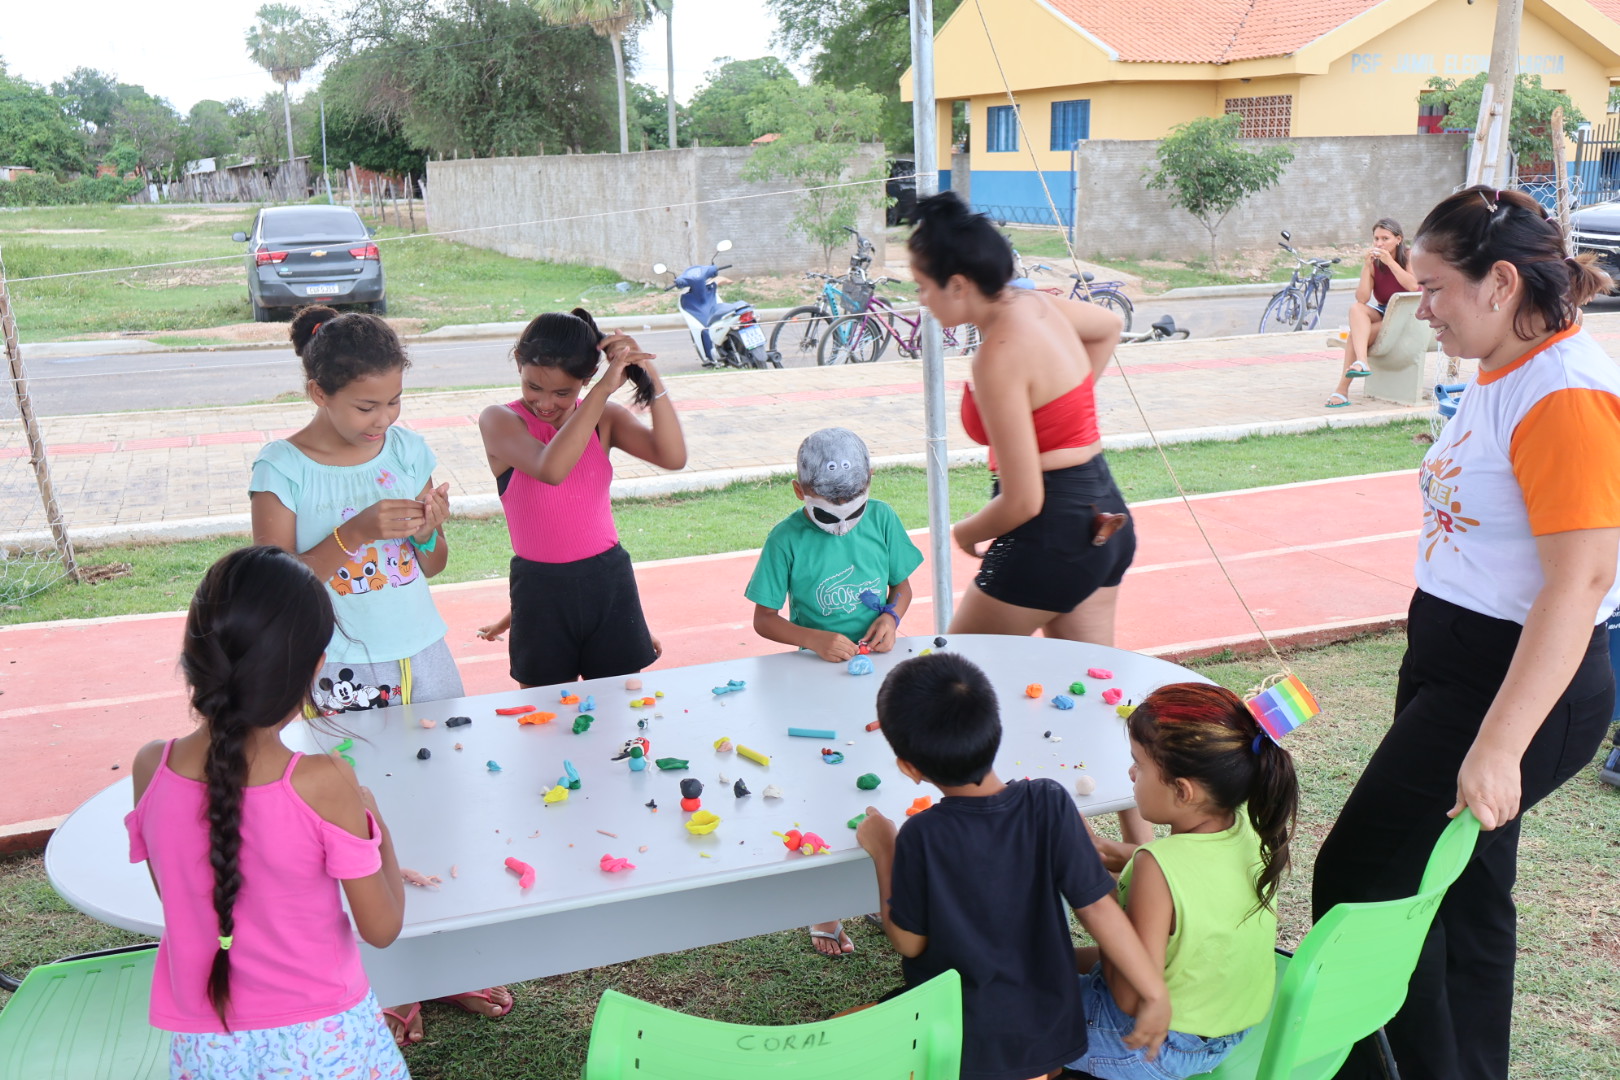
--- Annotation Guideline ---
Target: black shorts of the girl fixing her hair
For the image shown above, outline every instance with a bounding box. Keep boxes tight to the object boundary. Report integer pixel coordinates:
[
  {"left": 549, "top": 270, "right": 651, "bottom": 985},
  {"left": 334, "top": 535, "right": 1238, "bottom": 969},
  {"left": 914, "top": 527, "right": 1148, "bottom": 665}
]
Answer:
[{"left": 507, "top": 544, "right": 658, "bottom": 687}]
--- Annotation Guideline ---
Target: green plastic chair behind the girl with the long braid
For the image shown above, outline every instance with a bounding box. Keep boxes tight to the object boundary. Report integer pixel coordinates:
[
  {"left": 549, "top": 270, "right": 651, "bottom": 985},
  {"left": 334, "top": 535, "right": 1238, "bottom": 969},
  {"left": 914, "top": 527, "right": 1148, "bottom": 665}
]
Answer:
[{"left": 0, "top": 944, "right": 170, "bottom": 1080}]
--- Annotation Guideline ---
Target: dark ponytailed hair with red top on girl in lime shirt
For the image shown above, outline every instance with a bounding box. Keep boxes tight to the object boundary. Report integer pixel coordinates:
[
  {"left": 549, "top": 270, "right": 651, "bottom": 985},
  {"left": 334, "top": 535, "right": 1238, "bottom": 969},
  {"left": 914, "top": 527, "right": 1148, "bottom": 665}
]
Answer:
[{"left": 1129, "top": 683, "right": 1299, "bottom": 908}]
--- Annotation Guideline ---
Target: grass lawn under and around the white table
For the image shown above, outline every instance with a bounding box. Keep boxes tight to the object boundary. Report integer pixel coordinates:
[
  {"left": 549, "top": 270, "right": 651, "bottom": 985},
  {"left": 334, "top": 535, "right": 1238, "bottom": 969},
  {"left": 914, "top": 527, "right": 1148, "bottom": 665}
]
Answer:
[{"left": 0, "top": 635, "right": 1620, "bottom": 1080}]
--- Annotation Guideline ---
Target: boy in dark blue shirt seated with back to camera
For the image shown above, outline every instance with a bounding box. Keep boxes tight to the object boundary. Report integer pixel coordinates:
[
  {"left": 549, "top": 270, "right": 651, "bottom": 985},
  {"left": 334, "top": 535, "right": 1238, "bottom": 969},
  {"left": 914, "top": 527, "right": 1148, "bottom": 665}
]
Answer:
[{"left": 855, "top": 653, "right": 1170, "bottom": 1080}]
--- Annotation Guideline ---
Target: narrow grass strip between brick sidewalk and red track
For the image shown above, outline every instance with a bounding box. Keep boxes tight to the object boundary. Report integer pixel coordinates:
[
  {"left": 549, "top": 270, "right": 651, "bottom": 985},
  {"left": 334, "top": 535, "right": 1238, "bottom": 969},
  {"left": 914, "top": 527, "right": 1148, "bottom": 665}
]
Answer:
[{"left": 12, "top": 421, "right": 1429, "bottom": 623}]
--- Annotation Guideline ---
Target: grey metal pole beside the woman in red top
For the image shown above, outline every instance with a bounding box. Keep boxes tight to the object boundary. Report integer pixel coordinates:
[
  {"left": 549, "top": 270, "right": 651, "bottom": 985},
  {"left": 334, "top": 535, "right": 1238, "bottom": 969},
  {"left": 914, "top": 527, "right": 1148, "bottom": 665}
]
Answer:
[{"left": 910, "top": 0, "right": 956, "bottom": 633}]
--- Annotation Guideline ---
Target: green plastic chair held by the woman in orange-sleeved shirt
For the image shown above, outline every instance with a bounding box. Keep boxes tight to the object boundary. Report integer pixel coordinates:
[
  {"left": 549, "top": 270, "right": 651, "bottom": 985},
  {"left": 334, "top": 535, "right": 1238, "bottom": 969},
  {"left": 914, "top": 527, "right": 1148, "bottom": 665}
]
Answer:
[{"left": 1205, "top": 810, "right": 1479, "bottom": 1080}]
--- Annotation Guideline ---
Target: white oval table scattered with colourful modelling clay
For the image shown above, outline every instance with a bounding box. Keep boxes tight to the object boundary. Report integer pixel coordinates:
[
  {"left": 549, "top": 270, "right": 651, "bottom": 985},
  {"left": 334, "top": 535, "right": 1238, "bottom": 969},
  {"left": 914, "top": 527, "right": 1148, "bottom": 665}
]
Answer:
[{"left": 45, "top": 635, "right": 1207, "bottom": 1002}]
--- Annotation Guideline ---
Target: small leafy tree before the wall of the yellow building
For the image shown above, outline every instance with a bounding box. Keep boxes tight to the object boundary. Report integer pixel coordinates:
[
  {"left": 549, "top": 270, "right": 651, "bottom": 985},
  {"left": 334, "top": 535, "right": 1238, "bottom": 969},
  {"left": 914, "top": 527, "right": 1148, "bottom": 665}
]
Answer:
[{"left": 1147, "top": 113, "right": 1294, "bottom": 266}]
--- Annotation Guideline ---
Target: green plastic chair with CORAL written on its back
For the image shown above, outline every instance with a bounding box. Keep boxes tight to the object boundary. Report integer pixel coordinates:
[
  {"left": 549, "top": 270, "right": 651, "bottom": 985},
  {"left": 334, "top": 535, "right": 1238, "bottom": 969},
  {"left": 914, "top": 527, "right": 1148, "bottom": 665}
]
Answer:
[{"left": 585, "top": 972, "right": 962, "bottom": 1080}]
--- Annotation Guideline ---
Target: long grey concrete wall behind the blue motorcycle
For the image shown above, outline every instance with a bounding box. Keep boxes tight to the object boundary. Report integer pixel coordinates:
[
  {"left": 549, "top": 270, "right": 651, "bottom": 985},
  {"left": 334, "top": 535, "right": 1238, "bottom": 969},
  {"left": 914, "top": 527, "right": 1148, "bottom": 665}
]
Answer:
[{"left": 428, "top": 146, "right": 885, "bottom": 280}]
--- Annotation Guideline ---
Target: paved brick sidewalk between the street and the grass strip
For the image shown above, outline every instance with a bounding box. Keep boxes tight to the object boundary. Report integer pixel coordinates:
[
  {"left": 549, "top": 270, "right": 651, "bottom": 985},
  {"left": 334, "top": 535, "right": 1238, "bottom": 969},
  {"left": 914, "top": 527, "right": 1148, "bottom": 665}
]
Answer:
[{"left": 0, "top": 314, "right": 1535, "bottom": 534}]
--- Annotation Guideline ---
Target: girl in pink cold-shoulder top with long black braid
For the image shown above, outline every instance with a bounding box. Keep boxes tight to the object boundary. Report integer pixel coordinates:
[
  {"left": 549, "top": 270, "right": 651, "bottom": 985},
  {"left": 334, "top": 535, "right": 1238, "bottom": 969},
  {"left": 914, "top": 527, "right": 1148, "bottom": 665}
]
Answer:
[{"left": 125, "top": 547, "right": 408, "bottom": 1080}]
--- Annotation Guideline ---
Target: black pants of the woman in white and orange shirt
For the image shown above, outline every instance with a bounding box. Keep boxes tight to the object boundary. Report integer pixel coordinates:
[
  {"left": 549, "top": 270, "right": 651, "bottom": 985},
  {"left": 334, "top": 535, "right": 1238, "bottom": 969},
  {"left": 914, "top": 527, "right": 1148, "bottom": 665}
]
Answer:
[{"left": 1311, "top": 591, "right": 1615, "bottom": 1080}]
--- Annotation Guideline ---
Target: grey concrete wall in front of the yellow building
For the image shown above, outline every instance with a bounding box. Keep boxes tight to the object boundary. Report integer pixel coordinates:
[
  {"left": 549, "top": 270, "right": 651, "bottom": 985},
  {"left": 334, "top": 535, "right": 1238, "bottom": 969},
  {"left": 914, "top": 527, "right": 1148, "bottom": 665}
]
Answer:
[{"left": 1075, "top": 134, "right": 1466, "bottom": 257}]
